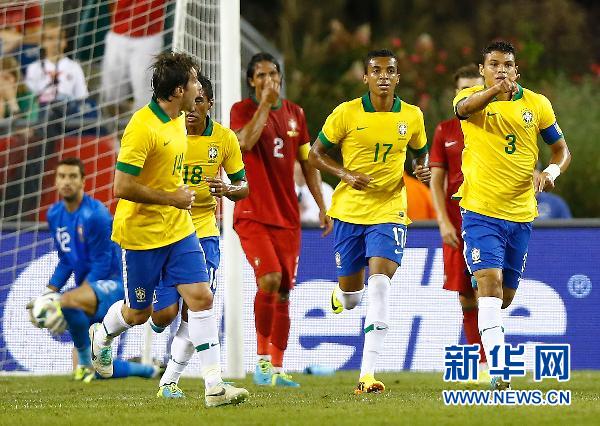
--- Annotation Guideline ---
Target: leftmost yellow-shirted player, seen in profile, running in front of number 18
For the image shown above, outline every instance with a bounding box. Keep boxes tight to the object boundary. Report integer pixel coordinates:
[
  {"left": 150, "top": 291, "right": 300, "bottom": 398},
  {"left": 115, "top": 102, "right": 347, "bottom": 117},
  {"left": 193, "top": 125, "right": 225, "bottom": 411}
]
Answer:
[{"left": 90, "top": 52, "right": 248, "bottom": 407}]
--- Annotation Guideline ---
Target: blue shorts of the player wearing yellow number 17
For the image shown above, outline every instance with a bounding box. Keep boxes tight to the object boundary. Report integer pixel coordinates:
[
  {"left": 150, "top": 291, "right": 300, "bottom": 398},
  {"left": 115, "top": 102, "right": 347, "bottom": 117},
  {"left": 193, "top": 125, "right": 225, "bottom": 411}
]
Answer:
[{"left": 333, "top": 219, "right": 406, "bottom": 277}]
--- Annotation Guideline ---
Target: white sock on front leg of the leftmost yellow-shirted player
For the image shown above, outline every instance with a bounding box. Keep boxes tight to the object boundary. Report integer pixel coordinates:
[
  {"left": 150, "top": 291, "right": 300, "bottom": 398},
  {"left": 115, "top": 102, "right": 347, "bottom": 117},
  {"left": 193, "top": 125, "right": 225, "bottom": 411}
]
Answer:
[{"left": 188, "top": 309, "right": 223, "bottom": 389}]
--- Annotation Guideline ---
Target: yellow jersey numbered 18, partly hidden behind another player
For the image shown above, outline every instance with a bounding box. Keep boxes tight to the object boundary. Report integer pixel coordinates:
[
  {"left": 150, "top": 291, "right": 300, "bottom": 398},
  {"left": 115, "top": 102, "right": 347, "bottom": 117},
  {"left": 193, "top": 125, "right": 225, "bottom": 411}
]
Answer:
[{"left": 183, "top": 117, "right": 245, "bottom": 238}]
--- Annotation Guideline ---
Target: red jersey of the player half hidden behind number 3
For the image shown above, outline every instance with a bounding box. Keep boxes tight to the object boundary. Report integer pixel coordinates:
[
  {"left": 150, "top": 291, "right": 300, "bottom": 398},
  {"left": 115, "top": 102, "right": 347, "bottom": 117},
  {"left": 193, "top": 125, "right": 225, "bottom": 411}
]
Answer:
[{"left": 429, "top": 118, "right": 465, "bottom": 229}]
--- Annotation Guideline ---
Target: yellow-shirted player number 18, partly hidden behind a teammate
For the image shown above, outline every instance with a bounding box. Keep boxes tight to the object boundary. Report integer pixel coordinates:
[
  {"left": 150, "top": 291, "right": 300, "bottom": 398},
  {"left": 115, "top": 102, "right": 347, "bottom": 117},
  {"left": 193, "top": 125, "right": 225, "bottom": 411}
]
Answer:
[{"left": 150, "top": 75, "right": 249, "bottom": 398}]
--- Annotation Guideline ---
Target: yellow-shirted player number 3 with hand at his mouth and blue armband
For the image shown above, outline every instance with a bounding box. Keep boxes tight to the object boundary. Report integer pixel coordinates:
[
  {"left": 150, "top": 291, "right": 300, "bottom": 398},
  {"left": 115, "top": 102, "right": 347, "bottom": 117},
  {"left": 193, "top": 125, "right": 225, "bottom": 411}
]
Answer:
[{"left": 453, "top": 41, "right": 571, "bottom": 390}]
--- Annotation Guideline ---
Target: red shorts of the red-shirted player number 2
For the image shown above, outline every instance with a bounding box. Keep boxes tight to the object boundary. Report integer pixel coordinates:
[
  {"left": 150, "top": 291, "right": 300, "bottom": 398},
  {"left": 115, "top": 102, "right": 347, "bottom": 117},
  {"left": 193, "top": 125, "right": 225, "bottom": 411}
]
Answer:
[{"left": 234, "top": 219, "right": 300, "bottom": 290}]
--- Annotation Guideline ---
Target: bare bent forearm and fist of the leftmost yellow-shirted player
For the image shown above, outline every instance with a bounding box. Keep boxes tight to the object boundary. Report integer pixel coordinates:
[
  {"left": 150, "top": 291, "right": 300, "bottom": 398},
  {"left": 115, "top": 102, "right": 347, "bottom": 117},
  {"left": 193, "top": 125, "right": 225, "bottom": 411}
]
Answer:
[{"left": 113, "top": 169, "right": 195, "bottom": 210}]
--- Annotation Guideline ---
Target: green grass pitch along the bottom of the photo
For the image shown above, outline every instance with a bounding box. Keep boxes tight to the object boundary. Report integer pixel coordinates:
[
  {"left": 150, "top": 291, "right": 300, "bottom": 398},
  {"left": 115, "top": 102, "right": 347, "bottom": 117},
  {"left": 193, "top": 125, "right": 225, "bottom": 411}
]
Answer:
[{"left": 0, "top": 371, "right": 600, "bottom": 426}]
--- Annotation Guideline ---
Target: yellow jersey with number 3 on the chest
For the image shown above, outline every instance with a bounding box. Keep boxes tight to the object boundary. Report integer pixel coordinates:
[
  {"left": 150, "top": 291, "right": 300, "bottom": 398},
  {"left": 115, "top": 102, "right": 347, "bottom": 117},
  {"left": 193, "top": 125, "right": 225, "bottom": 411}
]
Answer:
[{"left": 453, "top": 85, "right": 562, "bottom": 222}]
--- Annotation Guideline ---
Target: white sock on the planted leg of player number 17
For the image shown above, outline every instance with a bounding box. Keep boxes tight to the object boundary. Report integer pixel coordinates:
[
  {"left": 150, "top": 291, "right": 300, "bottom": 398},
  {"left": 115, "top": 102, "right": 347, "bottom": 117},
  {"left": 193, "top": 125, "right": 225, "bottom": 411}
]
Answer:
[{"left": 360, "top": 274, "right": 392, "bottom": 377}]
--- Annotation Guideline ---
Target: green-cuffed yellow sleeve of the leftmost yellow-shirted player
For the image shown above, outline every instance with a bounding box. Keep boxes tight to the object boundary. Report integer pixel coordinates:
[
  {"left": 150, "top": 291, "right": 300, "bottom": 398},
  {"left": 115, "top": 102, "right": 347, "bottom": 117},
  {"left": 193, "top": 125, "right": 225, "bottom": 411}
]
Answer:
[{"left": 117, "top": 116, "right": 155, "bottom": 176}]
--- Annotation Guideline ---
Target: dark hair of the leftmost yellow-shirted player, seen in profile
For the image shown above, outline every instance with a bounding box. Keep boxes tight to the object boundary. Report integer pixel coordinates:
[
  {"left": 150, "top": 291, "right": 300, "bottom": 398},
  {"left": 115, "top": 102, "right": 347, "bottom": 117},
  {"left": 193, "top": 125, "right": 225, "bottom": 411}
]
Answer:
[{"left": 151, "top": 52, "right": 200, "bottom": 101}]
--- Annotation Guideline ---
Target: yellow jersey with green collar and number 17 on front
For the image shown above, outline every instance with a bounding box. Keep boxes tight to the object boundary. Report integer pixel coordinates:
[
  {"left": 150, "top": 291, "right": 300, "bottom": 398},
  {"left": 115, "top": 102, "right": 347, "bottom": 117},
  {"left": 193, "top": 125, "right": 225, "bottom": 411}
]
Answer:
[{"left": 319, "top": 93, "right": 427, "bottom": 225}]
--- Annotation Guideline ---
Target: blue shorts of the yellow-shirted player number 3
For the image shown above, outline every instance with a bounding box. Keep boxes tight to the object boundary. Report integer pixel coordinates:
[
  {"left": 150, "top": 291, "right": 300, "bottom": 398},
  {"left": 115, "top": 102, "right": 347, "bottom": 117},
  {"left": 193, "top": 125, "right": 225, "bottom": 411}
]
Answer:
[{"left": 461, "top": 209, "right": 532, "bottom": 289}]
